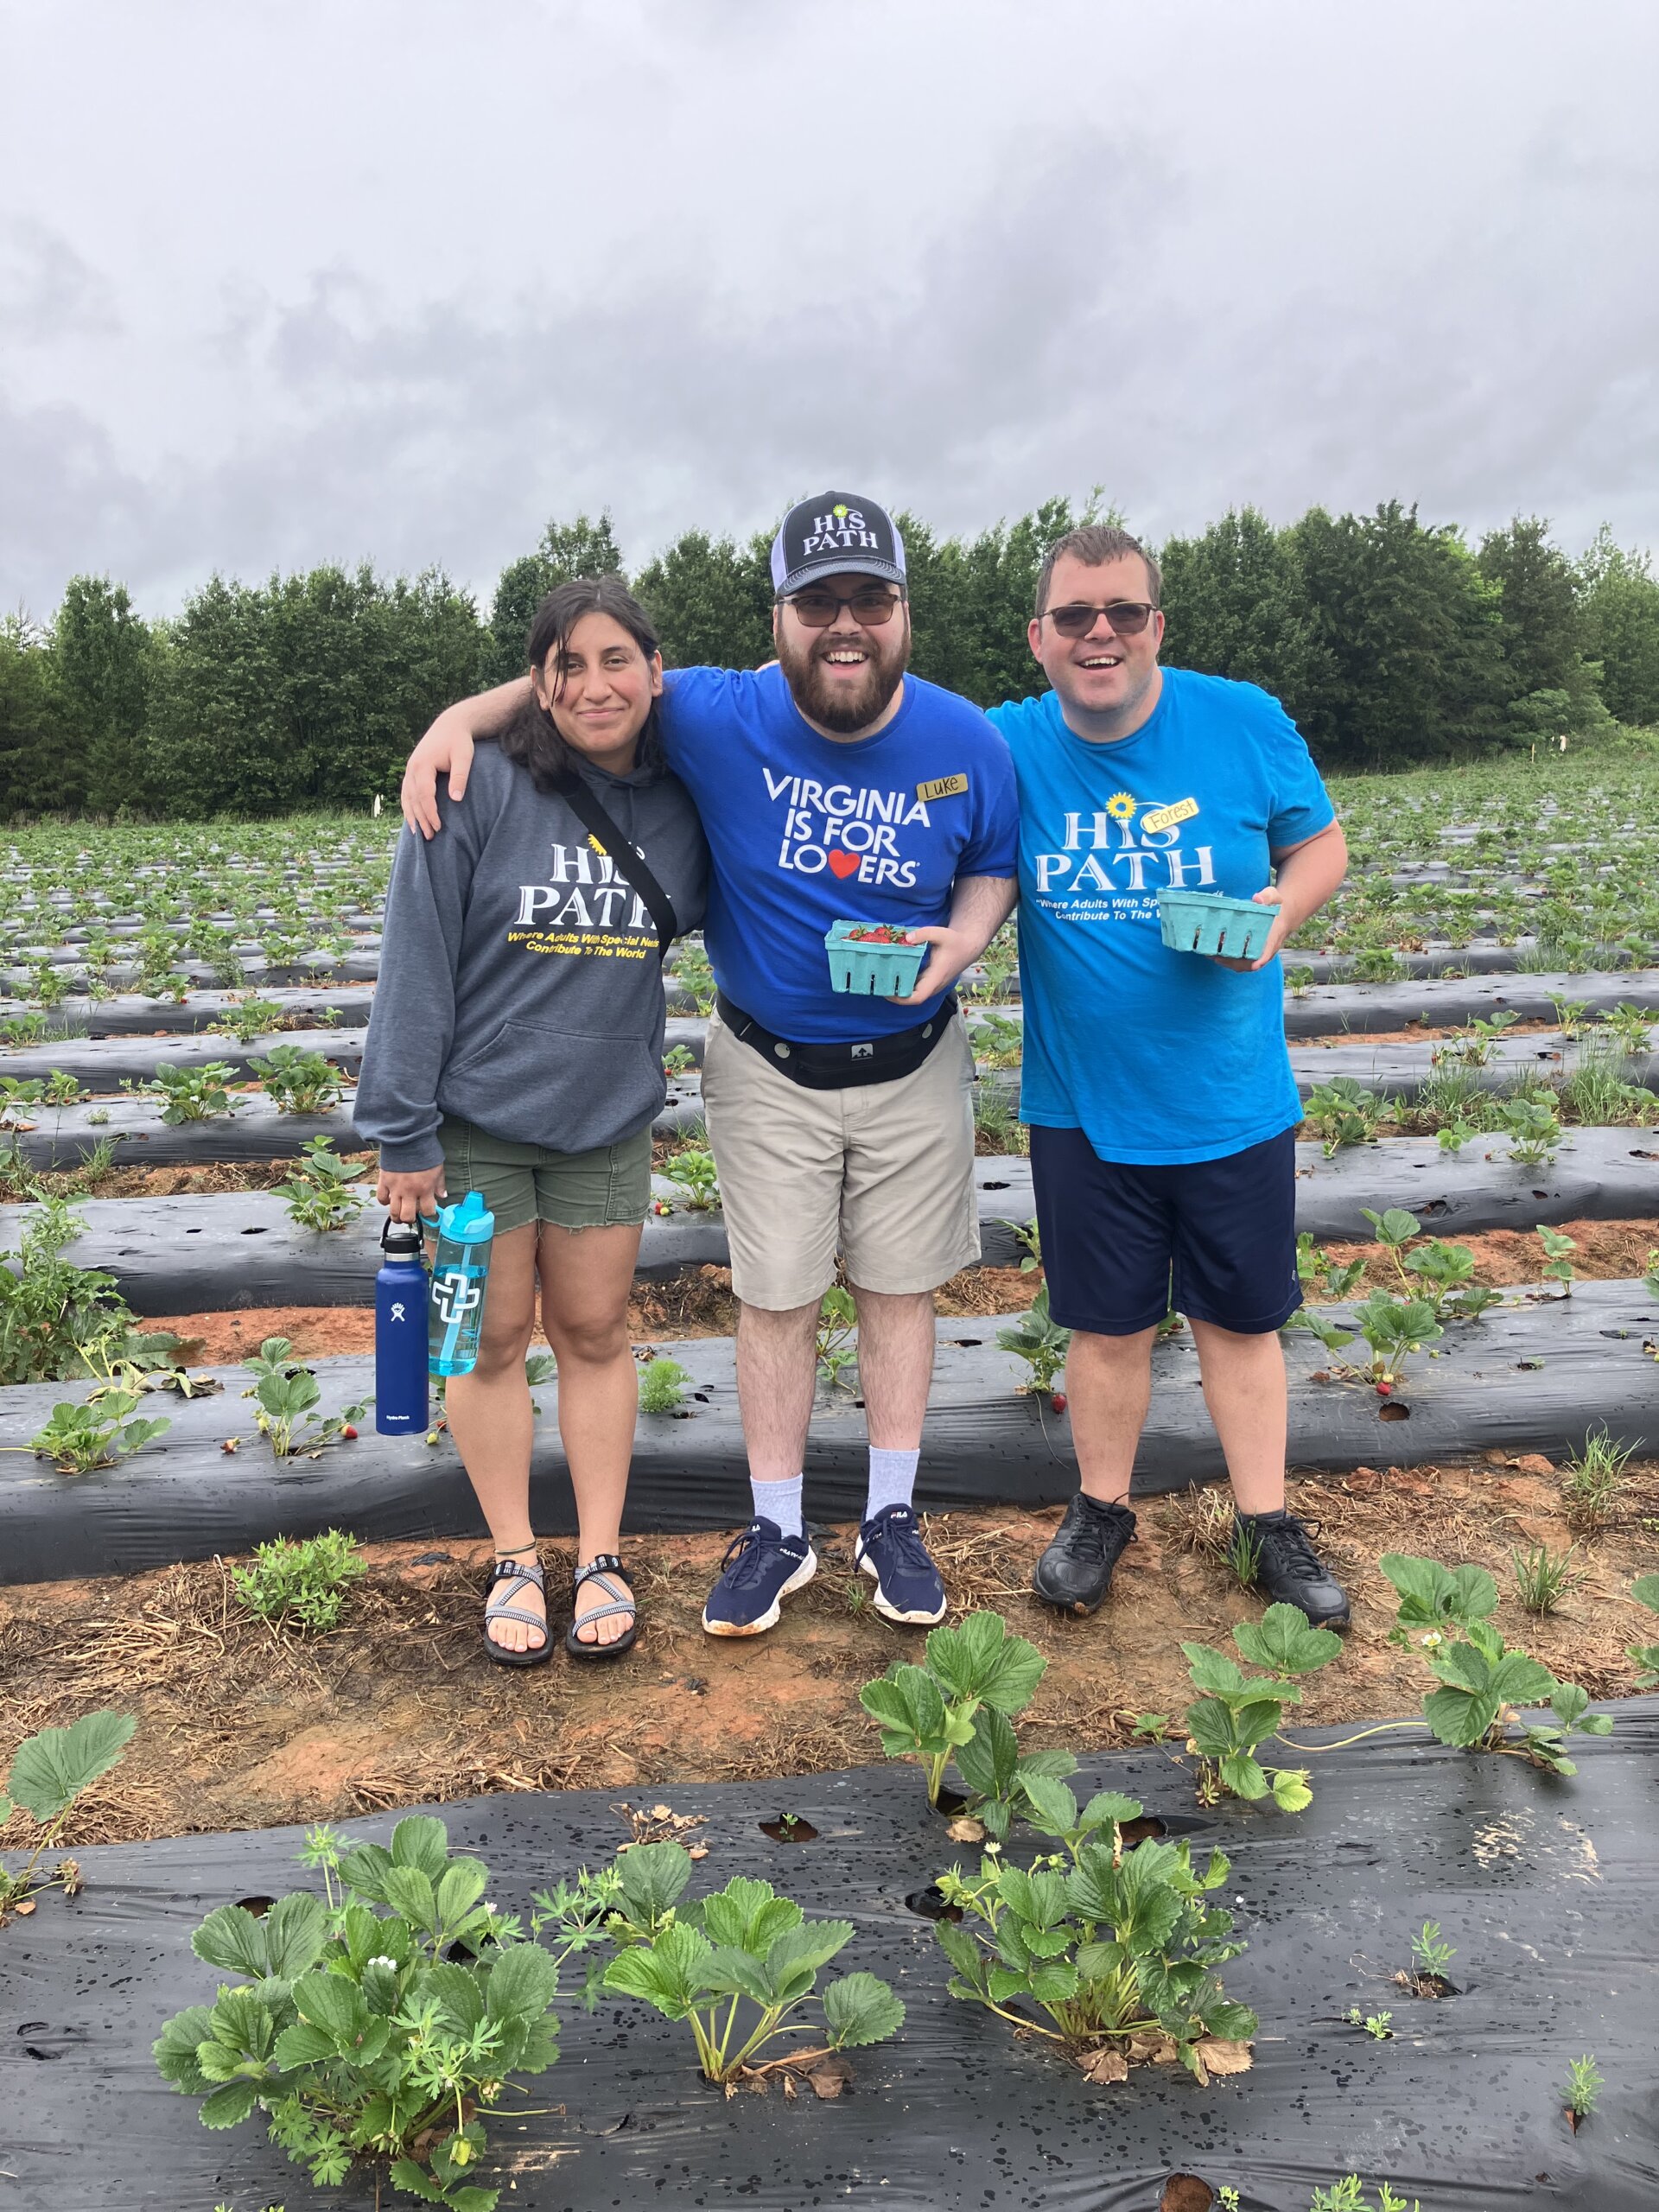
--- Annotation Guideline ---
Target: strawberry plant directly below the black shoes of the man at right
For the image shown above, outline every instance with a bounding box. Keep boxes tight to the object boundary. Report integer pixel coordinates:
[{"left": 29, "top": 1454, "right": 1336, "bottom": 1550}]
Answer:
[{"left": 1181, "top": 1606, "right": 1343, "bottom": 1812}]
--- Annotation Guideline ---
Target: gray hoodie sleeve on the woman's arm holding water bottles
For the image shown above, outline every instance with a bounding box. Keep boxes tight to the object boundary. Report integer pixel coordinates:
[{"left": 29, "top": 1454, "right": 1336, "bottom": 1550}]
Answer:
[{"left": 352, "top": 777, "right": 489, "bottom": 1174}]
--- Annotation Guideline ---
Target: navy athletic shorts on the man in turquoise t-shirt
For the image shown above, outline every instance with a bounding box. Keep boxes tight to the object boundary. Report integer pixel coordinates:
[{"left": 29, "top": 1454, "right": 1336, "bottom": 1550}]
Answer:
[{"left": 1031, "top": 1126, "right": 1303, "bottom": 1336}]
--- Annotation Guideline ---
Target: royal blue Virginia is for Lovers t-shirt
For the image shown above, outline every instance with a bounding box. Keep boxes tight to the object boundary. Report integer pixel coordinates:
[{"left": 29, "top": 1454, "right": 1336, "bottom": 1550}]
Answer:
[{"left": 661, "top": 668, "right": 1018, "bottom": 1044}]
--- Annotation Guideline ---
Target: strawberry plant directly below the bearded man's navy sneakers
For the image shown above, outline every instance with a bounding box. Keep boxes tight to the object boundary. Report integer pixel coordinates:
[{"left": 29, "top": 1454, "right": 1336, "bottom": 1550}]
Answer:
[{"left": 858, "top": 1612, "right": 1075, "bottom": 1836}]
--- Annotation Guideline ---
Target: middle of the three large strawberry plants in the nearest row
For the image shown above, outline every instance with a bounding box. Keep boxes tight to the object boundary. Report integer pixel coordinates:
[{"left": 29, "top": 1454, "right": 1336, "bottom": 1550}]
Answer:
[{"left": 604, "top": 1842, "right": 905, "bottom": 2086}]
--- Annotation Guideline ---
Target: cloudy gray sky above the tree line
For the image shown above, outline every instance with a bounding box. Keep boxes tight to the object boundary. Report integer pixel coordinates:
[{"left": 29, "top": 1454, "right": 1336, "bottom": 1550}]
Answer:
[{"left": 0, "top": 0, "right": 1659, "bottom": 615}]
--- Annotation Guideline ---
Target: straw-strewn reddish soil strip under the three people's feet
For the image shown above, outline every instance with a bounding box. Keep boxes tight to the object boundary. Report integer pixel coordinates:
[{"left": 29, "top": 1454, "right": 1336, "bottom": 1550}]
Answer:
[{"left": 0, "top": 1455, "right": 1659, "bottom": 1845}]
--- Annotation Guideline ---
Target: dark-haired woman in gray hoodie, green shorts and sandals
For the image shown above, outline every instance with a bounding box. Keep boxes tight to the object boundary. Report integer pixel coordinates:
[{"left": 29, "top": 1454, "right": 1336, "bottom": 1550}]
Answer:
[{"left": 354, "top": 577, "right": 708, "bottom": 1666}]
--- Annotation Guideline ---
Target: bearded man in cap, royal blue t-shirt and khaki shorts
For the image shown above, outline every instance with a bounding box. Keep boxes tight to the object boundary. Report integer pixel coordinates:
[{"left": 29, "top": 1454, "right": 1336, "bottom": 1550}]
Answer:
[{"left": 404, "top": 491, "right": 1018, "bottom": 1637}]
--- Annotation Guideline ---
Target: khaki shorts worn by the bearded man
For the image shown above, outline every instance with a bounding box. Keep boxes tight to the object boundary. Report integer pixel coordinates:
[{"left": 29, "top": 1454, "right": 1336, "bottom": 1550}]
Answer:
[{"left": 703, "top": 1013, "right": 980, "bottom": 1312}]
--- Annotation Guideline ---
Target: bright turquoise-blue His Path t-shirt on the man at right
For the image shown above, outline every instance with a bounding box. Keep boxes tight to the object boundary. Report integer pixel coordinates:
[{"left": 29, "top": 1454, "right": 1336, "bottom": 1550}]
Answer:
[{"left": 991, "top": 668, "right": 1336, "bottom": 1166}]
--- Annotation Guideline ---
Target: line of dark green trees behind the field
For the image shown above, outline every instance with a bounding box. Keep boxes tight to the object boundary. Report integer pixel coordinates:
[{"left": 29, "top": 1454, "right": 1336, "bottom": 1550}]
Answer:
[{"left": 0, "top": 498, "right": 1659, "bottom": 818}]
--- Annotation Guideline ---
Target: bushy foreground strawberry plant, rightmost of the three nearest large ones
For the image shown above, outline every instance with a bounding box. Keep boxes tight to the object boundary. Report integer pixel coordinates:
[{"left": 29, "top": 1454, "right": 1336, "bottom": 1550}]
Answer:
[{"left": 933, "top": 1785, "right": 1256, "bottom": 2084}]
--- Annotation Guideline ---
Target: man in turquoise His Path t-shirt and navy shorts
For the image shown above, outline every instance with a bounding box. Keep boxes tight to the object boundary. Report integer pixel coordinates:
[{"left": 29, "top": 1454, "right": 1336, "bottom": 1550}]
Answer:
[{"left": 991, "top": 524, "right": 1347, "bottom": 1624}]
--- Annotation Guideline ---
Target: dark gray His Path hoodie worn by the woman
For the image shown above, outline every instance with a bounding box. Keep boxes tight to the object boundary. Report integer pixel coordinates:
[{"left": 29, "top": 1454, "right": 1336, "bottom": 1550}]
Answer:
[{"left": 352, "top": 746, "right": 708, "bottom": 1173}]
